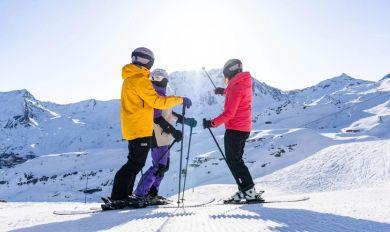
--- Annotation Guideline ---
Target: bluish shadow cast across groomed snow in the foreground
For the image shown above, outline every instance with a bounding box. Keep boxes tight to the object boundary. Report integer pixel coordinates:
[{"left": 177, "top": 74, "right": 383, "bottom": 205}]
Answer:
[{"left": 9, "top": 205, "right": 390, "bottom": 232}]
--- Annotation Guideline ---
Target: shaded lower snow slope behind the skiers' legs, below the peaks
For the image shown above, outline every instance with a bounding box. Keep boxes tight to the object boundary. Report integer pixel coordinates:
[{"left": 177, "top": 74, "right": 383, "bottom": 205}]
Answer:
[{"left": 0, "top": 129, "right": 334, "bottom": 201}]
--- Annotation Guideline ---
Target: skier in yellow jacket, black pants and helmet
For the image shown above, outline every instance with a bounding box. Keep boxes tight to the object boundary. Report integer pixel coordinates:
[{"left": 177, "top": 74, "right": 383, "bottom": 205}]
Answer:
[{"left": 106, "top": 47, "right": 192, "bottom": 208}]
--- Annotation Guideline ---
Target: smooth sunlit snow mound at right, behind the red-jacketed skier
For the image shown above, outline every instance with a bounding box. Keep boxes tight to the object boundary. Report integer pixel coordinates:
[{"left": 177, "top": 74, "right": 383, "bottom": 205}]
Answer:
[{"left": 260, "top": 139, "right": 390, "bottom": 192}]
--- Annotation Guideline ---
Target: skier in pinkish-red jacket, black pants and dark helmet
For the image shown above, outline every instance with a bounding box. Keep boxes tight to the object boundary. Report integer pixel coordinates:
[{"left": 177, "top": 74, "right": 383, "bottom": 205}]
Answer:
[{"left": 203, "top": 59, "right": 263, "bottom": 203}]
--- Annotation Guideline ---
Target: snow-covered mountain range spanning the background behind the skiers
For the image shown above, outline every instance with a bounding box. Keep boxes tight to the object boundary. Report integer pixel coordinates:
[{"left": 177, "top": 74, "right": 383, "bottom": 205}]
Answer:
[{"left": 0, "top": 69, "right": 390, "bottom": 201}]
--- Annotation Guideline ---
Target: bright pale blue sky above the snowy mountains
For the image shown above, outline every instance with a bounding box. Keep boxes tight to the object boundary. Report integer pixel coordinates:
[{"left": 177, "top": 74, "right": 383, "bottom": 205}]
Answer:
[{"left": 0, "top": 0, "right": 390, "bottom": 103}]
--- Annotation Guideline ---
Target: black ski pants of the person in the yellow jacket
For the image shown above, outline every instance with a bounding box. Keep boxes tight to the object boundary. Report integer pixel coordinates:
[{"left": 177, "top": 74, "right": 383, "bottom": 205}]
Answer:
[{"left": 111, "top": 137, "right": 152, "bottom": 200}]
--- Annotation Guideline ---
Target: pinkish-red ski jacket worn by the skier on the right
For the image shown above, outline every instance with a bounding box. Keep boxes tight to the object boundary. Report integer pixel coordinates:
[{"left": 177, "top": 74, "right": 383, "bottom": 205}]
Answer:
[{"left": 211, "top": 72, "right": 252, "bottom": 132}]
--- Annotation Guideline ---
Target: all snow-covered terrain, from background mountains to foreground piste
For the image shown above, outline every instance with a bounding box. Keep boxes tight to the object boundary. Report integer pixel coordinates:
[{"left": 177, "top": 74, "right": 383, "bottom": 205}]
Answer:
[{"left": 0, "top": 70, "right": 390, "bottom": 231}]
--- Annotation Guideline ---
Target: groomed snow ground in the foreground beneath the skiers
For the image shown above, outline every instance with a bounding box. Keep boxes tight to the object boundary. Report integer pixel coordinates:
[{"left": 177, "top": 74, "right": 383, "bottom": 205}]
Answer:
[{"left": 0, "top": 185, "right": 390, "bottom": 232}]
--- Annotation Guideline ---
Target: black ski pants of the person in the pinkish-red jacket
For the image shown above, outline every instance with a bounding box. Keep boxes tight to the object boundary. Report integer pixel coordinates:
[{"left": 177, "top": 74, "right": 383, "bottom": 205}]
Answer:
[{"left": 224, "top": 129, "right": 254, "bottom": 191}]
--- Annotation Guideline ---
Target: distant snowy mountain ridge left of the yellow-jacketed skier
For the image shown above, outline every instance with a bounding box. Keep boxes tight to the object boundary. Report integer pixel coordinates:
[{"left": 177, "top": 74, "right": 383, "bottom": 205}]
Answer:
[{"left": 0, "top": 90, "right": 124, "bottom": 168}]
